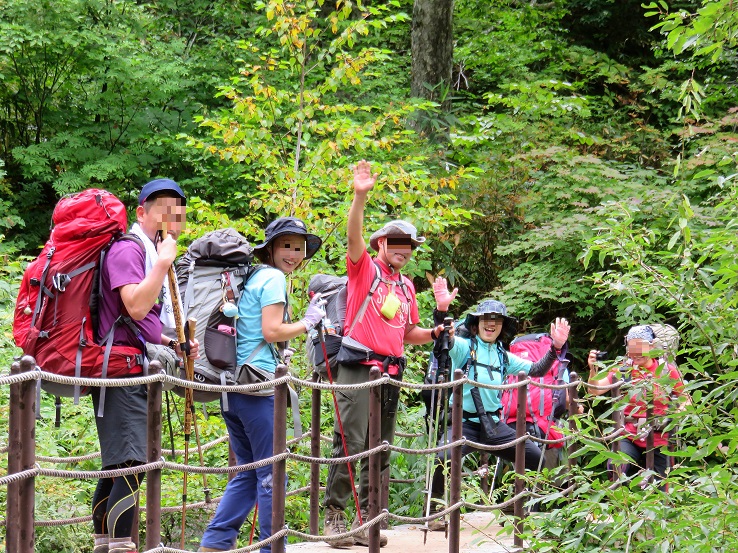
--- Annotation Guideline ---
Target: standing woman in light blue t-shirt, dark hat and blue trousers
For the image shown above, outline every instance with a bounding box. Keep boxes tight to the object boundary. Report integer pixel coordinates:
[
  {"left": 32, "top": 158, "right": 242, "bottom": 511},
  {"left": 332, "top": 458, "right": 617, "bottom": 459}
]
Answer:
[{"left": 198, "top": 217, "right": 325, "bottom": 553}]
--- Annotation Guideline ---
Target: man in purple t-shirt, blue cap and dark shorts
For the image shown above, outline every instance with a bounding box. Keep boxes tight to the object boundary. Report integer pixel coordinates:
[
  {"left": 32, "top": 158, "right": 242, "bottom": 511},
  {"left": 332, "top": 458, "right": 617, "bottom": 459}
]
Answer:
[{"left": 91, "top": 179, "right": 199, "bottom": 553}]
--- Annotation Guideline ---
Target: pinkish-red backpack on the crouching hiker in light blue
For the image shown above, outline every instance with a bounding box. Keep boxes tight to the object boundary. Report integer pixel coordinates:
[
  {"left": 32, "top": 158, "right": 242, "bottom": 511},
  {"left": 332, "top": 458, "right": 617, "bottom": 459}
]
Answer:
[{"left": 501, "top": 333, "right": 568, "bottom": 448}]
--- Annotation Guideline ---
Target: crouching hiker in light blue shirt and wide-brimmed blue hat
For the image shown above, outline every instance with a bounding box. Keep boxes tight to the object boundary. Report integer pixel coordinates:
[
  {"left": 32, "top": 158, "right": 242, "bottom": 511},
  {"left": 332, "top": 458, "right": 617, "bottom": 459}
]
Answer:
[{"left": 420, "top": 283, "right": 569, "bottom": 531}]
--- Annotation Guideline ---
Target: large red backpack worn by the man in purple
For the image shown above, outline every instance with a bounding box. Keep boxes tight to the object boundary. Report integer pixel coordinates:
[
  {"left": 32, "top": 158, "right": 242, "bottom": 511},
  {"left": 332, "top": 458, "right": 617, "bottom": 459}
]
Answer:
[{"left": 13, "top": 189, "right": 145, "bottom": 403}]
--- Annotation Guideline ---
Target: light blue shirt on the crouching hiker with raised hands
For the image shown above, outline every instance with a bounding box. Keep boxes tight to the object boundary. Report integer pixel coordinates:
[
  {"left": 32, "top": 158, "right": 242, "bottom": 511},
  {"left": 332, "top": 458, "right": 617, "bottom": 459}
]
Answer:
[{"left": 449, "top": 336, "right": 533, "bottom": 421}]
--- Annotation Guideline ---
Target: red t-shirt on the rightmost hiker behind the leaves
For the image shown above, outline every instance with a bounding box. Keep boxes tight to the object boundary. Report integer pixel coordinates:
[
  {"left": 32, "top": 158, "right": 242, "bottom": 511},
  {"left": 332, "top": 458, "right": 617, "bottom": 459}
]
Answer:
[{"left": 610, "top": 359, "right": 684, "bottom": 447}]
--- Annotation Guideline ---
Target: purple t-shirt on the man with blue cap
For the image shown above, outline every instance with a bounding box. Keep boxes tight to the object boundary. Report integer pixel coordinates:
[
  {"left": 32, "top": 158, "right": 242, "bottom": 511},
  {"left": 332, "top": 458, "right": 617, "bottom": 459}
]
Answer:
[{"left": 98, "top": 240, "right": 162, "bottom": 346}]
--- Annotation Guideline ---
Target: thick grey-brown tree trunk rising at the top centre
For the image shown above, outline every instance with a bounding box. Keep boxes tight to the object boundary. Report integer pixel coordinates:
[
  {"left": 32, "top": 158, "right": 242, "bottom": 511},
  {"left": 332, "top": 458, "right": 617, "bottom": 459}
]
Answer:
[{"left": 411, "top": 0, "right": 454, "bottom": 103}]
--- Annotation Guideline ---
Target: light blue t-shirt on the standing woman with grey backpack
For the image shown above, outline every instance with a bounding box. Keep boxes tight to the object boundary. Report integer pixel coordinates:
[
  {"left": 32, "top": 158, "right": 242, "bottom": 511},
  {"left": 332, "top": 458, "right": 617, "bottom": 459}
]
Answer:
[{"left": 236, "top": 267, "right": 287, "bottom": 372}]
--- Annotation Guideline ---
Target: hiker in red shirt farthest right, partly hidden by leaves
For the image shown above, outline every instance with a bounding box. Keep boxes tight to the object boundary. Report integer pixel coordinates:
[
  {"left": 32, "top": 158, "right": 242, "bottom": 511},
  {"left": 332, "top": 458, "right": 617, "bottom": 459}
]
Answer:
[{"left": 587, "top": 325, "right": 691, "bottom": 478}]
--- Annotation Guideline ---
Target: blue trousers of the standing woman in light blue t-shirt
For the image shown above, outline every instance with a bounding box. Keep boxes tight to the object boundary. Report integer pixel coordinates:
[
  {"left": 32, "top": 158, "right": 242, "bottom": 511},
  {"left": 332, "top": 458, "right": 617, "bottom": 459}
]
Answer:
[{"left": 200, "top": 392, "right": 284, "bottom": 553}]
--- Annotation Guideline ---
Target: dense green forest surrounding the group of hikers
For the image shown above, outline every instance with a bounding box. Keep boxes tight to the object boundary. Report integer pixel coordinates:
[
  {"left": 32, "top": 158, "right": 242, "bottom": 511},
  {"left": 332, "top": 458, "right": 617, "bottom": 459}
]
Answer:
[{"left": 0, "top": 0, "right": 738, "bottom": 552}]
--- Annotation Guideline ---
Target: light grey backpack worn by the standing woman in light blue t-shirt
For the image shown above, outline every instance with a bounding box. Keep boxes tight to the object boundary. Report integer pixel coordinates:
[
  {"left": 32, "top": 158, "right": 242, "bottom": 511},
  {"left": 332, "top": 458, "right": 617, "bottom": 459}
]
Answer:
[{"left": 174, "top": 228, "right": 263, "bottom": 410}]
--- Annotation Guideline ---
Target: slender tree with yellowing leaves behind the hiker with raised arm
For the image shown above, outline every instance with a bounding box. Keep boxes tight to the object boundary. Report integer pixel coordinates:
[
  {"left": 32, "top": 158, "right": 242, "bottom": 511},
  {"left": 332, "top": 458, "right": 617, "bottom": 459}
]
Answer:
[{"left": 184, "top": 2, "right": 469, "bottom": 284}]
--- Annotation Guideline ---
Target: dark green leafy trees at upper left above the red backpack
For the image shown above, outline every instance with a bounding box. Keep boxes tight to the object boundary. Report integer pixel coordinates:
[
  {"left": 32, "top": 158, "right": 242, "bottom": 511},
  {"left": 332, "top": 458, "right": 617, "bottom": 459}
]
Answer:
[{"left": 0, "top": 0, "right": 262, "bottom": 251}]
